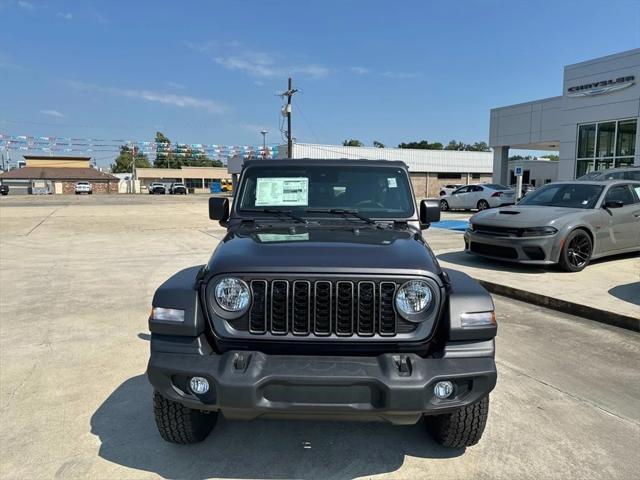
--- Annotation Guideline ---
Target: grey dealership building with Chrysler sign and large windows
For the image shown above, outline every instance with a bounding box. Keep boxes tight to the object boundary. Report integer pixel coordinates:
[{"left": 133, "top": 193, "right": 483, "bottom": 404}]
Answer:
[{"left": 489, "top": 49, "right": 640, "bottom": 183}]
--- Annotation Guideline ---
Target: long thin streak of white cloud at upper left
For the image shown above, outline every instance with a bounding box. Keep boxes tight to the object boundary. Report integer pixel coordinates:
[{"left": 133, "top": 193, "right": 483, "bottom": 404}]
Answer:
[{"left": 67, "top": 81, "right": 229, "bottom": 113}]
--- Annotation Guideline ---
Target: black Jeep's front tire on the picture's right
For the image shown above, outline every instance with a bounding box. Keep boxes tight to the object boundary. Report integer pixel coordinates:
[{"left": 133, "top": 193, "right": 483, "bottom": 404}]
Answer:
[{"left": 426, "top": 395, "right": 489, "bottom": 448}]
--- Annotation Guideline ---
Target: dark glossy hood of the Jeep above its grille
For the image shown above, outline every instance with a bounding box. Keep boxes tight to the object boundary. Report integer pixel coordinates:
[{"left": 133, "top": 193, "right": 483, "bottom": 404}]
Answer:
[{"left": 208, "top": 226, "right": 441, "bottom": 275}]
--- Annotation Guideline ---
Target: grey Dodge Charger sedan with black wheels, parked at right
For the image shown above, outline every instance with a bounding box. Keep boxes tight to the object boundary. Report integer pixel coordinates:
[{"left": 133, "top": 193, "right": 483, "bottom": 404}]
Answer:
[{"left": 464, "top": 180, "right": 640, "bottom": 272}]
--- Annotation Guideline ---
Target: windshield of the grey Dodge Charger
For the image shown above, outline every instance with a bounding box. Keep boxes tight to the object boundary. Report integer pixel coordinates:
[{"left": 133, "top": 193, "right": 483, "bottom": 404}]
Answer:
[{"left": 518, "top": 183, "right": 604, "bottom": 208}]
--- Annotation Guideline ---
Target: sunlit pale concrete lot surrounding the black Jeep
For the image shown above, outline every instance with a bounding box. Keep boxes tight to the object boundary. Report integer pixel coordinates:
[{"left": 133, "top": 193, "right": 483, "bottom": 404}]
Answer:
[{"left": 0, "top": 195, "right": 640, "bottom": 479}]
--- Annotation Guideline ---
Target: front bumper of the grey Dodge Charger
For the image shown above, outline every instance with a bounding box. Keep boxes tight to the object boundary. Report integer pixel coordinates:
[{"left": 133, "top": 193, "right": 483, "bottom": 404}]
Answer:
[{"left": 464, "top": 230, "right": 561, "bottom": 265}]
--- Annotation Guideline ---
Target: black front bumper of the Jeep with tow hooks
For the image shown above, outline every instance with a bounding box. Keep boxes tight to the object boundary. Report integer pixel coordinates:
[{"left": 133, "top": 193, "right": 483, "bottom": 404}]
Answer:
[{"left": 147, "top": 348, "right": 496, "bottom": 424}]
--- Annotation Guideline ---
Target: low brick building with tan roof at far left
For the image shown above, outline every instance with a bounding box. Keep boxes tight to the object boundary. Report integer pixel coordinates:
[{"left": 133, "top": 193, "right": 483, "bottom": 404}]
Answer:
[{"left": 0, "top": 155, "right": 120, "bottom": 195}]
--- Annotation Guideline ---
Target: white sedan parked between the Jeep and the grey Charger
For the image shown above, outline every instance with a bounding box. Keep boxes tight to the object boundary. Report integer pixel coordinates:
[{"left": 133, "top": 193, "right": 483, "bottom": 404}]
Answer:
[{"left": 440, "top": 183, "right": 516, "bottom": 212}]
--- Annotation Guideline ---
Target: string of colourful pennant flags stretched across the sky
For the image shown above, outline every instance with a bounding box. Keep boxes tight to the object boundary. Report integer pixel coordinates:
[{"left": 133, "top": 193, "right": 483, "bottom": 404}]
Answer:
[{"left": 0, "top": 133, "right": 278, "bottom": 163}]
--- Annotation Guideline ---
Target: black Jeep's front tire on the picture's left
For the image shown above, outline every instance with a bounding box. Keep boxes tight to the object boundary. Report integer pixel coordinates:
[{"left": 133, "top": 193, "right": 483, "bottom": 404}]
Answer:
[{"left": 153, "top": 392, "right": 218, "bottom": 444}]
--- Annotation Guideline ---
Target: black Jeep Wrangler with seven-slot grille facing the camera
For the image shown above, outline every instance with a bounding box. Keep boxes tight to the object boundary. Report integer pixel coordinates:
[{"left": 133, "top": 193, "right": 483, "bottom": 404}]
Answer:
[{"left": 147, "top": 160, "right": 497, "bottom": 448}]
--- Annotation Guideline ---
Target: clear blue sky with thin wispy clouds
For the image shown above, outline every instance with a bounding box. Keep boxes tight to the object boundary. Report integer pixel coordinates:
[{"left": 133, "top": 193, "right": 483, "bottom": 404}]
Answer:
[{"left": 0, "top": 0, "right": 640, "bottom": 166}]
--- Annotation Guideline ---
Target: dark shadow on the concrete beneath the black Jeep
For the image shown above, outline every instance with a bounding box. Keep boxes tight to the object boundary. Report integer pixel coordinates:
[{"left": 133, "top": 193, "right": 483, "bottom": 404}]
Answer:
[{"left": 91, "top": 375, "right": 464, "bottom": 479}]
